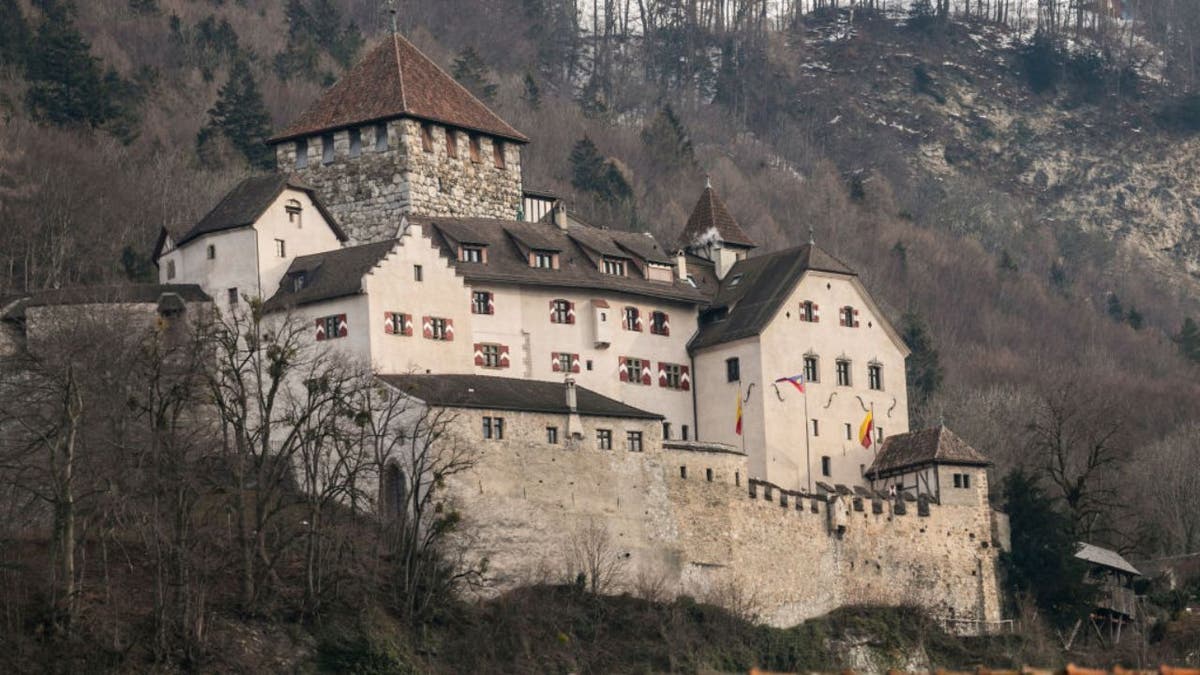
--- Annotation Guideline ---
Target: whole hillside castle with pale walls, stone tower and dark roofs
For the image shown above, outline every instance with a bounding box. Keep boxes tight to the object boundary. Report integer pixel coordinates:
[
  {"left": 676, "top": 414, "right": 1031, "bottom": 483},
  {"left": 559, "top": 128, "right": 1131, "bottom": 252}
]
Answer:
[{"left": 7, "top": 35, "right": 1004, "bottom": 631}]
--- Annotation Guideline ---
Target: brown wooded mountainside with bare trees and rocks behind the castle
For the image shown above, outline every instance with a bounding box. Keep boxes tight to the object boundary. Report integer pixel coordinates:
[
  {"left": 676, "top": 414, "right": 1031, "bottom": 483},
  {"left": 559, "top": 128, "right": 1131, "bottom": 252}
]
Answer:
[{"left": 0, "top": 0, "right": 1200, "bottom": 555}]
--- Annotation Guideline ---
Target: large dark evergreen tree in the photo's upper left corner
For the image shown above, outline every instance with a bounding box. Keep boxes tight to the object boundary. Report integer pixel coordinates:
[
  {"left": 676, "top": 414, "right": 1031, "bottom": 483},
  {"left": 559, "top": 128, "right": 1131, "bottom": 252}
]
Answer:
[{"left": 24, "top": 2, "right": 119, "bottom": 127}]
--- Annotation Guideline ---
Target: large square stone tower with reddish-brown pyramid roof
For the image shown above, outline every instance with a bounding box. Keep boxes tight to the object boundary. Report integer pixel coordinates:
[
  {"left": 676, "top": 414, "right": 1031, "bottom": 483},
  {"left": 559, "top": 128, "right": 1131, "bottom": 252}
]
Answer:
[{"left": 269, "top": 35, "right": 528, "bottom": 244}]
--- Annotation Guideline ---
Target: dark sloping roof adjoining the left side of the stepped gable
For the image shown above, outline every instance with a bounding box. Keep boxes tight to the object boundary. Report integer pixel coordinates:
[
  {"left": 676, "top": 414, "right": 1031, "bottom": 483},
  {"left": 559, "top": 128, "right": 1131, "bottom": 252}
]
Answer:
[{"left": 263, "top": 239, "right": 397, "bottom": 311}]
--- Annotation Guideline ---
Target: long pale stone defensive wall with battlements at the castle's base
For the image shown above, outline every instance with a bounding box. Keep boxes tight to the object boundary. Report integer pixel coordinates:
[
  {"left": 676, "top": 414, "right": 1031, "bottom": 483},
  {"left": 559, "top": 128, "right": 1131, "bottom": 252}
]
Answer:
[{"left": 451, "top": 425, "right": 1001, "bottom": 626}]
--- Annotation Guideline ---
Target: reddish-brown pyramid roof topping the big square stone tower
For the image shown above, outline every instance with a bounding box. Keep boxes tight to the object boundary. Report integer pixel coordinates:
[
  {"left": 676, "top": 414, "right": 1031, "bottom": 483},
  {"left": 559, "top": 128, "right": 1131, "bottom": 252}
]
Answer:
[{"left": 276, "top": 35, "right": 529, "bottom": 143}]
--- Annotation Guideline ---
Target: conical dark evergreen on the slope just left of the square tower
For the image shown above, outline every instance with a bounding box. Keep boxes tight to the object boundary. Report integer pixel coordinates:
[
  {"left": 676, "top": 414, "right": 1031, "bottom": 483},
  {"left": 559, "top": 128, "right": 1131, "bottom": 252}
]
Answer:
[{"left": 196, "top": 59, "right": 275, "bottom": 168}]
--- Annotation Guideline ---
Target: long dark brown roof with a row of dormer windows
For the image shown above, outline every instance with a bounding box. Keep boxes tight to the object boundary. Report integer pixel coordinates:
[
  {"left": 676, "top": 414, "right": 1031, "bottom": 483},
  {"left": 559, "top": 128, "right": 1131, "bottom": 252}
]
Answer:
[{"left": 410, "top": 217, "right": 706, "bottom": 304}]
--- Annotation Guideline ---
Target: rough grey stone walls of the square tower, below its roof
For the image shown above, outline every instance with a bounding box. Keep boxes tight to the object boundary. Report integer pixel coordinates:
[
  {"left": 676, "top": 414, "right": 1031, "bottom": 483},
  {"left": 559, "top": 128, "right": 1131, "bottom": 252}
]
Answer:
[{"left": 275, "top": 119, "right": 522, "bottom": 244}]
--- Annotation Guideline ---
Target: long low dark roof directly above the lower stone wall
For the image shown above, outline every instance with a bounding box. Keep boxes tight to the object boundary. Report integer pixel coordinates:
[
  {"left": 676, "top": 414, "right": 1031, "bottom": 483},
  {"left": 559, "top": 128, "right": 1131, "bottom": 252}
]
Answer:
[{"left": 379, "top": 375, "right": 662, "bottom": 419}]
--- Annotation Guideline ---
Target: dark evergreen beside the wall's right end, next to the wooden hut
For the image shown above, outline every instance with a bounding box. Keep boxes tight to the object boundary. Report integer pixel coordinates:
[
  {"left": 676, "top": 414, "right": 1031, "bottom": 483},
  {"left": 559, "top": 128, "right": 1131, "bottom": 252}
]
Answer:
[{"left": 1001, "top": 470, "right": 1096, "bottom": 629}]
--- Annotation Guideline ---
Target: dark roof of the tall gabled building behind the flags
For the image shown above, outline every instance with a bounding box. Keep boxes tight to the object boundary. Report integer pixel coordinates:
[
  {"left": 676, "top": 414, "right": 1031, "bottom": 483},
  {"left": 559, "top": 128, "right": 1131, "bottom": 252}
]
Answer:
[{"left": 689, "top": 244, "right": 854, "bottom": 351}]
